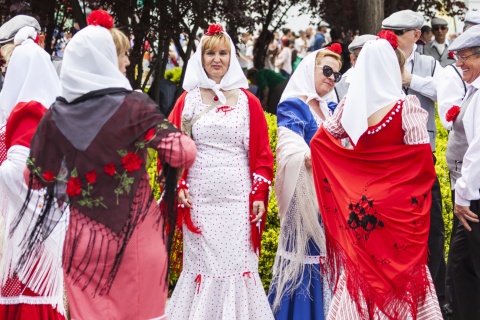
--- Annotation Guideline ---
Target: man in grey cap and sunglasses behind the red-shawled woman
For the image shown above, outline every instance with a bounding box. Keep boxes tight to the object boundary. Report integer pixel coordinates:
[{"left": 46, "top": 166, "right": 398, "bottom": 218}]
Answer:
[{"left": 382, "top": 10, "right": 446, "bottom": 316}]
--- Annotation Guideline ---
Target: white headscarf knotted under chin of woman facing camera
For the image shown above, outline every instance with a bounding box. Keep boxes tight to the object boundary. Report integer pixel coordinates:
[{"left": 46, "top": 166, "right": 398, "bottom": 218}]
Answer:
[{"left": 183, "top": 32, "right": 248, "bottom": 103}]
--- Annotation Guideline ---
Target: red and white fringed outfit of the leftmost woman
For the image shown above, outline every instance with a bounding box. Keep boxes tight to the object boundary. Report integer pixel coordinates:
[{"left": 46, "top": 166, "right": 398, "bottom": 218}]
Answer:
[{"left": 0, "top": 101, "right": 67, "bottom": 320}]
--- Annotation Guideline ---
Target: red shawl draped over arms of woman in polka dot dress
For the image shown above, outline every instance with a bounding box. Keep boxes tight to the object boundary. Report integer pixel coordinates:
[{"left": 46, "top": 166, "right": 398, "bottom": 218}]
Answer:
[{"left": 168, "top": 89, "right": 273, "bottom": 254}]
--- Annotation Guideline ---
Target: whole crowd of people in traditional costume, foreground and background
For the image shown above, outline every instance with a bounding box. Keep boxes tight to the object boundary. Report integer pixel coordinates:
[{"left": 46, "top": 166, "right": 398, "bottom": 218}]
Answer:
[{"left": 0, "top": 4, "right": 480, "bottom": 320}]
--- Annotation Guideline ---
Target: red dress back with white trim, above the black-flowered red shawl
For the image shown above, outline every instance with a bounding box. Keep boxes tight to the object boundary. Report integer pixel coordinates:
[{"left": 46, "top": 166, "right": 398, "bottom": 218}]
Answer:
[{"left": 352, "top": 102, "right": 405, "bottom": 150}]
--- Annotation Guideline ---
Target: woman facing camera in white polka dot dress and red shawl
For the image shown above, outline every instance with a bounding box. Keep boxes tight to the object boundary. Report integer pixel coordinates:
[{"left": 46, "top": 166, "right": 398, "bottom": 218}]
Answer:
[{"left": 167, "top": 25, "right": 273, "bottom": 320}]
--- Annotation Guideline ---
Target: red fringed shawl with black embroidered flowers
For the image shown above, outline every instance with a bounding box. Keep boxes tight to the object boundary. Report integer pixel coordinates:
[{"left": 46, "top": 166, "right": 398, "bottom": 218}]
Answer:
[{"left": 310, "top": 126, "right": 435, "bottom": 319}]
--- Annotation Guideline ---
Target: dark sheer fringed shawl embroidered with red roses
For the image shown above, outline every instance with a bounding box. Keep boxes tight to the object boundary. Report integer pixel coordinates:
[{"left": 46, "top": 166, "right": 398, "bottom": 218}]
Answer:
[{"left": 14, "top": 88, "right": 180, "bottom": 294}]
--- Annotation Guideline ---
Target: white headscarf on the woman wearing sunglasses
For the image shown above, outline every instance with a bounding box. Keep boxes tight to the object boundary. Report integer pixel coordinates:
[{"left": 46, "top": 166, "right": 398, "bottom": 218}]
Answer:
[{"left": 280, "top": 49, "right": 333, "bottom": 115}]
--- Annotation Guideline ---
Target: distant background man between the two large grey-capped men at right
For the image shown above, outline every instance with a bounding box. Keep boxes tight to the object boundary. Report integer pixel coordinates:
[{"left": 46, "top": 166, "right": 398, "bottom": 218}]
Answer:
[{"left": 423, "top": 18, "right": 455, "bottom": 67}]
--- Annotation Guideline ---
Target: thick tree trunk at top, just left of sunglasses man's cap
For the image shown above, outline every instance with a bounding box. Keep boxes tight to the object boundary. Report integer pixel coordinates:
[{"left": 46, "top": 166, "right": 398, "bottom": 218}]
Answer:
[{"left": 357, "top": 0, "right": 384, "bottom": 34}]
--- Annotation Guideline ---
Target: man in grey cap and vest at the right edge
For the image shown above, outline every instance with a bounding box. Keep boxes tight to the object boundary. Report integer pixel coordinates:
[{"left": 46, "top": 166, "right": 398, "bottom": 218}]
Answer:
[{"left": 447, "top": 25, "right": 480, "bottom": 320}]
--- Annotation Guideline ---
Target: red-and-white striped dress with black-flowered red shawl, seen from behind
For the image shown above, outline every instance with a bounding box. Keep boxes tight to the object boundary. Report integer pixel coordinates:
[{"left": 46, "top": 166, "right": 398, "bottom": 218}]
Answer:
[{"left": 312, "top": 96, "right": 442, "bottom": 320}]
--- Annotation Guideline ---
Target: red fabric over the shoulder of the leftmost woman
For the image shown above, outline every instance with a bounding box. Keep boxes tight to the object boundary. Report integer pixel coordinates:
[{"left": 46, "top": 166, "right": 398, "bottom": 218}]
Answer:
[{"left": 5, "top": 101, "right": 47, "bottom": 150}]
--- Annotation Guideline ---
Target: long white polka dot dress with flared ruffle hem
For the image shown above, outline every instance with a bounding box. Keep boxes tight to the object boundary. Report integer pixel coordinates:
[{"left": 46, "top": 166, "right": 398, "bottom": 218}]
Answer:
[{"left": 167, "top": 88, "right": 273, "bottom": 320}]
